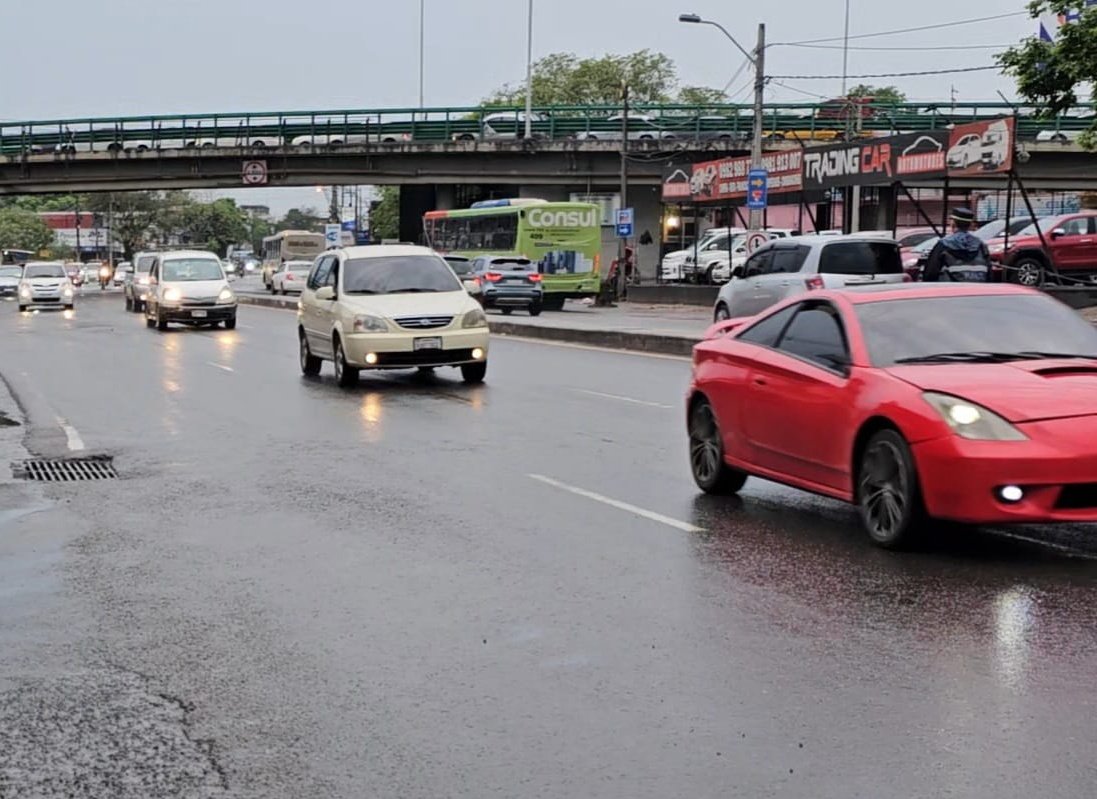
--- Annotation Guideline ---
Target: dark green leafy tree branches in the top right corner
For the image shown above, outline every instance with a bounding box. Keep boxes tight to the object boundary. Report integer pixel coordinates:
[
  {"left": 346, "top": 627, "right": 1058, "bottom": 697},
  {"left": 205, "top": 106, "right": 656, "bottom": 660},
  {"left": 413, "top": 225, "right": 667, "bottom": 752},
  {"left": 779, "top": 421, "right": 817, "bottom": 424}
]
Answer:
[{"left": 998, "top": 0, "right": 1097, "bottom": 149}]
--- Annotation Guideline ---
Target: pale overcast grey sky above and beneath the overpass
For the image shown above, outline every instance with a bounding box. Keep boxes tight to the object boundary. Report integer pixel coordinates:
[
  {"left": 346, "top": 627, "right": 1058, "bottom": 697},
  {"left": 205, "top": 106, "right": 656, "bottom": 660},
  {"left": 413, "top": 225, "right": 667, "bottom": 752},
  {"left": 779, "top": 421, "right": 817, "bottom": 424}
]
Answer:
[{"left": 0, "top": 0, "right": 1036, "bottom": 211}]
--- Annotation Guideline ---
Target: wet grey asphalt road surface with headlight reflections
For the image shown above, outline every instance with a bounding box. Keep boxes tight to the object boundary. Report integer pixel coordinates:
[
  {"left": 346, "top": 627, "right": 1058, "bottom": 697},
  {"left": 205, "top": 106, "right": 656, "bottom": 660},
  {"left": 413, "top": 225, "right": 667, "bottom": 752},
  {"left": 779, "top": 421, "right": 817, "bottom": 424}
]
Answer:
[{"left": 0, "top": 295, "right": 1097, "bottom": 799}]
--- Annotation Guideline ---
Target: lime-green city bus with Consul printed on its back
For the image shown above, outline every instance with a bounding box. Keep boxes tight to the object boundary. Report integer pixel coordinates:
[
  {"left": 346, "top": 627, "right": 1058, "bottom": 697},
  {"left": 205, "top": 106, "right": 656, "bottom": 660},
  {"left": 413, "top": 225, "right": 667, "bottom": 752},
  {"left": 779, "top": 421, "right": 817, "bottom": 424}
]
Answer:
[{"left": 422, "top": 199, "right": 602, "bottom": 311}]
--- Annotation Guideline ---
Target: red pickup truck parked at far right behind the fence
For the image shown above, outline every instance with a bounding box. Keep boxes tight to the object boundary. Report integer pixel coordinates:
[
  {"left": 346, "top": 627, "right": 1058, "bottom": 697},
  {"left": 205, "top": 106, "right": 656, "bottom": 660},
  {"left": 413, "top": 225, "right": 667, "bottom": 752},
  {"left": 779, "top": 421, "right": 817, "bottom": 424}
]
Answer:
[{"left": 989, "top": 211, "right": 1097, "bottom": 286}]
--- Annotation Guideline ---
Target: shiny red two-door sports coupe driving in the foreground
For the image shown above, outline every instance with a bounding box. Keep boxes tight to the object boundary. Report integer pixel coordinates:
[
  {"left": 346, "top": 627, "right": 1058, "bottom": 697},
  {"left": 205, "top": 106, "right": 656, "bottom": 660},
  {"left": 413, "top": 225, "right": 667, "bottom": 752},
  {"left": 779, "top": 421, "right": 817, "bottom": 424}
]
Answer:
[{"left": 688, "top": 283, "right": 1097, "bottom": 548}]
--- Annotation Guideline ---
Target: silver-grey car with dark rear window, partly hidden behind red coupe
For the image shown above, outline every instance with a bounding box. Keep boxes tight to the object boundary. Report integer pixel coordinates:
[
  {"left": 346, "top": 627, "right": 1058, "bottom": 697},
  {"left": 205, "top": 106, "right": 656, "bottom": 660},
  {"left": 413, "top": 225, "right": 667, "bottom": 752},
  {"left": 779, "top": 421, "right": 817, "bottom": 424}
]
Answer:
[{"left": 713, "top": 234, "right": 911, "bottom": 322}]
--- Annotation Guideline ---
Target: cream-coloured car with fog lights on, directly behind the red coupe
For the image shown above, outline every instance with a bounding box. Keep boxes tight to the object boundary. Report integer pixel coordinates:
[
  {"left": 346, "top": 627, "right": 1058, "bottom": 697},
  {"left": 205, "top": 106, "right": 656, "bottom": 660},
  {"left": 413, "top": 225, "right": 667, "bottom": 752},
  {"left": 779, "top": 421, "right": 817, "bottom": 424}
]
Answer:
[{"left": 297, "top": 245, "right": 488, "bottom": 387}]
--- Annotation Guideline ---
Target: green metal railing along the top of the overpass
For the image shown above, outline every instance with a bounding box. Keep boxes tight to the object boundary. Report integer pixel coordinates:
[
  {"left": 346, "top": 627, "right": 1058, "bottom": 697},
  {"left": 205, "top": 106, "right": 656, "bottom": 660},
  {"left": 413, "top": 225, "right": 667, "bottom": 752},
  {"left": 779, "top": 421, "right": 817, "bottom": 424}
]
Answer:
[{"left": 0, "top": 101, "right": 1094, "bottom": 158}]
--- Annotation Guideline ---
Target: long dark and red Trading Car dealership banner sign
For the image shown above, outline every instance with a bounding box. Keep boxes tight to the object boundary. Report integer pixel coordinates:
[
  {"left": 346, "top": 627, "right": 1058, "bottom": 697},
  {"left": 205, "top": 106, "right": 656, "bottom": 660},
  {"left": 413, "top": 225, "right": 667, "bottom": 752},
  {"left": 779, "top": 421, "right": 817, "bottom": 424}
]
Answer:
[{"left": 663, "top": 117, "right": 1015, "bottom": 202}]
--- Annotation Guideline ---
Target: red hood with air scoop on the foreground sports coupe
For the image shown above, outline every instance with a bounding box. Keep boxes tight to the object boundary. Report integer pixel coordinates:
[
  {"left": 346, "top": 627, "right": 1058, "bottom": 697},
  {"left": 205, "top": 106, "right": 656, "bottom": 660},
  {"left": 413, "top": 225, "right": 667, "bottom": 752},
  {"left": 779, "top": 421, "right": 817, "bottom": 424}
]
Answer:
[{"left": 886, "top": 359, "right": 1097, "bottom": 423}]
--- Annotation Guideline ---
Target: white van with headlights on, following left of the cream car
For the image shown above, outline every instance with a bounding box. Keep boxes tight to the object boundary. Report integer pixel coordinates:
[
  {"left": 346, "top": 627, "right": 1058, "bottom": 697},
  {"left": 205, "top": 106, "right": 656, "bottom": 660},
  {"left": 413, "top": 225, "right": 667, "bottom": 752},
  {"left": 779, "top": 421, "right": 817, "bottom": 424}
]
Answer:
[{"left": 145, "top": 250, "right": 236, "bottom": 330}]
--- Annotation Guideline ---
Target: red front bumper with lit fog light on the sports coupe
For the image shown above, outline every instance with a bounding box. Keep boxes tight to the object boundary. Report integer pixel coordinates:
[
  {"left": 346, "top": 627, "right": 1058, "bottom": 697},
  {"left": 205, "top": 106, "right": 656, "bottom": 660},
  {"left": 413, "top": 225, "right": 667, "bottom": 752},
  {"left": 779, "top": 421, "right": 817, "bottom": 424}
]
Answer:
[{"left": 913, "top": 416, "right": 1097, "bottom": 525}]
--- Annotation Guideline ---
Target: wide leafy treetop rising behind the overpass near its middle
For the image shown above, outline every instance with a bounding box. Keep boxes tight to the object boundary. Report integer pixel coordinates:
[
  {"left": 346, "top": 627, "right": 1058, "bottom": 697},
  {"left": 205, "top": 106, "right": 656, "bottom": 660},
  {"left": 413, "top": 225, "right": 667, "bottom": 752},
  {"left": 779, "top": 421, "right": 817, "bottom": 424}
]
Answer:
[{"left": 487, "top": 49, "right": 678, "bottom": 105}]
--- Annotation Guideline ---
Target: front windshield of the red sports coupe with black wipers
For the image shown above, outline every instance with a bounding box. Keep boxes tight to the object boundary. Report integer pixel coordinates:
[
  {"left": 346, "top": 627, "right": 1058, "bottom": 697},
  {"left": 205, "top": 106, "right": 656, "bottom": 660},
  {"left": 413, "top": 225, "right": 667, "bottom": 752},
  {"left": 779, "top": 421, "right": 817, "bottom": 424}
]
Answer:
[{"left": 856, "top": 294, "right": 1097, "bottom": 368}]
